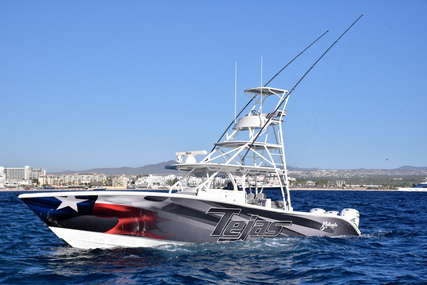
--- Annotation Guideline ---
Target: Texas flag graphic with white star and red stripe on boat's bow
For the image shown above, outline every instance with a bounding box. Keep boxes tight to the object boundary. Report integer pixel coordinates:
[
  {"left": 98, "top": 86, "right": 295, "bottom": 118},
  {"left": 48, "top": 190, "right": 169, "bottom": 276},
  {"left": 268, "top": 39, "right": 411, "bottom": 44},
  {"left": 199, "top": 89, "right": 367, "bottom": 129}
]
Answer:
[{"left": 22, "top": 195, "right": 168, "bottom": 239}]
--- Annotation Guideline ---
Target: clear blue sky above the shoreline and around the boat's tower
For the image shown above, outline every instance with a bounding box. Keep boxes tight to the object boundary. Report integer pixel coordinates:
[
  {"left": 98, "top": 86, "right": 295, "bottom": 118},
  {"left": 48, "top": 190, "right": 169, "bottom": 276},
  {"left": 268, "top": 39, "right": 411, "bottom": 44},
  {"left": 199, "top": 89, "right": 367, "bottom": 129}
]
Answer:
[{"left": 0, "top": 0, "right": 427, "bottom": 172}]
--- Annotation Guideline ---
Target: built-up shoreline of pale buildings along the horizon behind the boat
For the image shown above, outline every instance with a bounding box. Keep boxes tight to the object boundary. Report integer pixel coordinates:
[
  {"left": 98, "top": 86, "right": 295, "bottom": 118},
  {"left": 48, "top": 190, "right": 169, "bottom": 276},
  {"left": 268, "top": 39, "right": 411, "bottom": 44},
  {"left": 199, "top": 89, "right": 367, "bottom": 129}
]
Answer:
[{"left": 4, "top": 166, "right": 427, "bottom": 189}]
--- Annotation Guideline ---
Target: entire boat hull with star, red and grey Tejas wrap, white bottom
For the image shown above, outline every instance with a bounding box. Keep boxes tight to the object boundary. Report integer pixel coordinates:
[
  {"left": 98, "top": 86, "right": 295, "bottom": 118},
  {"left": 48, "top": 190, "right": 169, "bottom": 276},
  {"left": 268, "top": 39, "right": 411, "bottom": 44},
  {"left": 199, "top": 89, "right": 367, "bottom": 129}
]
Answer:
[{"left": 20, "top": 190, "right": 360, "bottom": 248}]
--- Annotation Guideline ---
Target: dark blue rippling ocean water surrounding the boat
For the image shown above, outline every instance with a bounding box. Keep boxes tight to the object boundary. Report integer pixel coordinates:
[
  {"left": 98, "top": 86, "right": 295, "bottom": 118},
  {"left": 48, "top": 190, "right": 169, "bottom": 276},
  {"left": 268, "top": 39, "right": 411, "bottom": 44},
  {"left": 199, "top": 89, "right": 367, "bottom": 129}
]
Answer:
[{"left": 0, "top": 191, "right": 427, "bottom": 285}]
